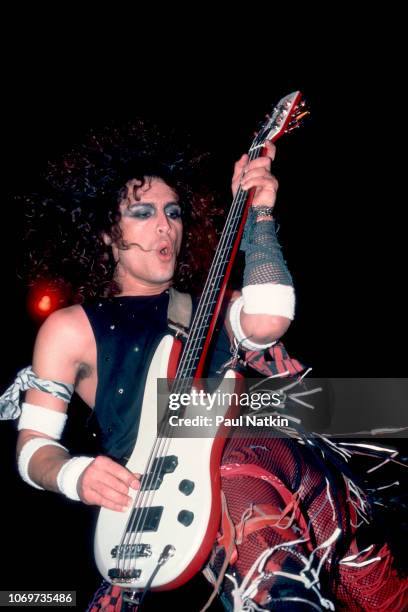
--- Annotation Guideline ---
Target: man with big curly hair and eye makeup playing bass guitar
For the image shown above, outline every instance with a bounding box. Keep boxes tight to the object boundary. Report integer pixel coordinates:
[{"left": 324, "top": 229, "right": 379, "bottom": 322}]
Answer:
[{"left": 1, "top": 118, "right": 403, "bottom": 610}]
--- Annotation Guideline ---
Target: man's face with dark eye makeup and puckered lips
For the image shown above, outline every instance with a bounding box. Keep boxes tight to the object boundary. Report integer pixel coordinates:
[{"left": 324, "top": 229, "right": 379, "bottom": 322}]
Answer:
[{"left": 112, "top": 178, "right": 183, "bottom": 295}]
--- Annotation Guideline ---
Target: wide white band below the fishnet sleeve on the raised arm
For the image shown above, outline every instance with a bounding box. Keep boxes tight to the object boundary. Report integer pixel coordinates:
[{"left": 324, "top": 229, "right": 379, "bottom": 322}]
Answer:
[{"left": 242, "top": 283, "right": 295, "bottom": 321}]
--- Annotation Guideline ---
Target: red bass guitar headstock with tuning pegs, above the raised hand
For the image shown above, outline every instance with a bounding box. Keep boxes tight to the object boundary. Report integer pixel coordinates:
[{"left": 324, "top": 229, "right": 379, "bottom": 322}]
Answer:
[{"left": 250, "top": 91, "right": 310, "bottom": 151}]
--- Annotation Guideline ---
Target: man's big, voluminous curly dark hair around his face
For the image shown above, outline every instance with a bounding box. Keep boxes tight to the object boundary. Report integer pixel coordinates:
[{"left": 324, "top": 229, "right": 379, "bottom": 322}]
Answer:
[{"left": 20, "top": 119, "right": 223, "bottom": 303}]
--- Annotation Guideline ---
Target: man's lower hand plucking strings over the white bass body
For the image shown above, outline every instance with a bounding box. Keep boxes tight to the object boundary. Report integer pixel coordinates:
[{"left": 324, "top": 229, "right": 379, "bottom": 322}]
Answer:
[{"left": 77, "top": 455, "right": 140, "bottom": 512}]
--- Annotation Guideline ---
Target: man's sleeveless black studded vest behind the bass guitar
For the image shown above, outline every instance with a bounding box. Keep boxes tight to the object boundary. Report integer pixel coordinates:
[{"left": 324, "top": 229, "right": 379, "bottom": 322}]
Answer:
[{"left": 83, "top": 291, "right": 231, "bottom": 460}]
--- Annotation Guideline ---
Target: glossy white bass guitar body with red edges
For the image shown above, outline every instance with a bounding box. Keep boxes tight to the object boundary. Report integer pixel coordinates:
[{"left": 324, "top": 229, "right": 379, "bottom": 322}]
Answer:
[{"left": 94, "top": 335, "right": 239, "bottom": 589}]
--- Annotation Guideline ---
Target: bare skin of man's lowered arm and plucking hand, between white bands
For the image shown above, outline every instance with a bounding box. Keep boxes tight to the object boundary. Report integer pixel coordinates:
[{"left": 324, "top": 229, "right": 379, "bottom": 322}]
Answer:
[{"left": 17, "top": 306, "right": 139, "bottom": 510}]
